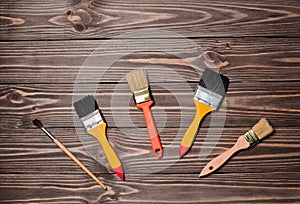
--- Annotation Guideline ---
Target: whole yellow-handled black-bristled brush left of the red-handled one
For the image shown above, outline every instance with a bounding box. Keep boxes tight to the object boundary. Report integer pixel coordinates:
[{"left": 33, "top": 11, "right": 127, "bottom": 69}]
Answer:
[{"left": 74, "top": 96, "right": 125, "bottom": 180}]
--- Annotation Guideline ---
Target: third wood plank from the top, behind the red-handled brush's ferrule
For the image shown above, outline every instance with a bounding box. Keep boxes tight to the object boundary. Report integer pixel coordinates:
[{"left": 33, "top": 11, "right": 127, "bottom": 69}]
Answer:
[{"left": 0, "top": 81, "right": 300, "bottom": 128}]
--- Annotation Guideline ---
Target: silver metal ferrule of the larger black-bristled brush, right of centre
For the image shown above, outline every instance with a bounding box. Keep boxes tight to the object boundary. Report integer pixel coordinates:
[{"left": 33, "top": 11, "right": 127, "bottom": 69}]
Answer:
[{"left": 194, "top": 85, "right": 223, "bottom": 109}]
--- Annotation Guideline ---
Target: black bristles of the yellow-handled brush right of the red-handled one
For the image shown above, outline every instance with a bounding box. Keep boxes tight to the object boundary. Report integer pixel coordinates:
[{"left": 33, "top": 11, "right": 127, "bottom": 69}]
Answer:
[{"left": 199, "top": 69, "right": 229, "bottom": 96}]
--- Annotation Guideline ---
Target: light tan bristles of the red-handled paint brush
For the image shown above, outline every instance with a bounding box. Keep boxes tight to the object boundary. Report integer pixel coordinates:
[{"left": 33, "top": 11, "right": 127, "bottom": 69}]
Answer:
[{"left": 126, "top": 69, "right": 148, "bottom": 92}]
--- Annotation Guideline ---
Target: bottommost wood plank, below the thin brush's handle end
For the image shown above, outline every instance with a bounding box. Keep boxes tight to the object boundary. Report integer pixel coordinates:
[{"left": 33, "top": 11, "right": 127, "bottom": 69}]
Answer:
[{"left": 3, "top": 173, "right": 299, "bottom": 203}]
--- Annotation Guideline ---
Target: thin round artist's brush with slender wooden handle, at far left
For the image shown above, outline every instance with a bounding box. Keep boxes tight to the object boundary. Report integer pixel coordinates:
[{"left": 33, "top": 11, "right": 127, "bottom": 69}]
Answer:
[{"left": 32, "top": 119, "right": 107, "bottom": 190}]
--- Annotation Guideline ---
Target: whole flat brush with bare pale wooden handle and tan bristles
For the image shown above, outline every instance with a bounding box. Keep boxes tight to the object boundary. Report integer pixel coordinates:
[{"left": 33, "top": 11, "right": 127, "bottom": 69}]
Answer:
[{"left": 199, "top": 118, "right": 273, "bottom": 177}]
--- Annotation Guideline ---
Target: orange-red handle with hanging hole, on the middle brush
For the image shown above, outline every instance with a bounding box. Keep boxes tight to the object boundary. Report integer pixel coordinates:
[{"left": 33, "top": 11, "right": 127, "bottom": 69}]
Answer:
[{"left": 136, "top": 100, "right": 163, "bottom": 158}]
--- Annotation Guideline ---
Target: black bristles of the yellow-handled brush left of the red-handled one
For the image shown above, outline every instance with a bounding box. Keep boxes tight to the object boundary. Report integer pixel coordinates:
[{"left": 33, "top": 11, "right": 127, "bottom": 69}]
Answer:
[{"left": 74, "top": 95, "right": 99, "bottom": 118}]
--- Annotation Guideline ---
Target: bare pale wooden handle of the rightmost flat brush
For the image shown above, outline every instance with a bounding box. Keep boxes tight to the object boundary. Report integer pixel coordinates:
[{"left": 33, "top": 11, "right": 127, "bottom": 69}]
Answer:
[{"left": 199, "top": 135, "right": 250, "bottom": 177}]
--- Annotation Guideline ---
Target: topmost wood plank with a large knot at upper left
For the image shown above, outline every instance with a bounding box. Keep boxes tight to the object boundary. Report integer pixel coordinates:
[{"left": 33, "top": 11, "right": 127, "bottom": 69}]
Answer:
[{"left": 0, "top": 0, "right": 300, "bottom": 40}]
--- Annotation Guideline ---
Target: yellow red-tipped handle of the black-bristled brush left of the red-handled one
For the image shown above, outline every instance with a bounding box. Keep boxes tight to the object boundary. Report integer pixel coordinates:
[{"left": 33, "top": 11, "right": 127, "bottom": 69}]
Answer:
[{"left": 88, "top": 123, "right": 124, "bottom": 180}]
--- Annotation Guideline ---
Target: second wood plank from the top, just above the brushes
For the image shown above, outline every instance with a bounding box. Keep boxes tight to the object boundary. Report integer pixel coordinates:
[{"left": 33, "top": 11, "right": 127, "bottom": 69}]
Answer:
[{"left": 0, "top": 38, "right": 300, "bottom": 85}]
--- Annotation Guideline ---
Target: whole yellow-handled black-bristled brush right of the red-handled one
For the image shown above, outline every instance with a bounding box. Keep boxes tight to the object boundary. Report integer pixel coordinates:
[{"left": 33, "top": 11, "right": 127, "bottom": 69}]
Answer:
[{"left": 179, "top": 69, "right": 229, "bottom": 158}]
